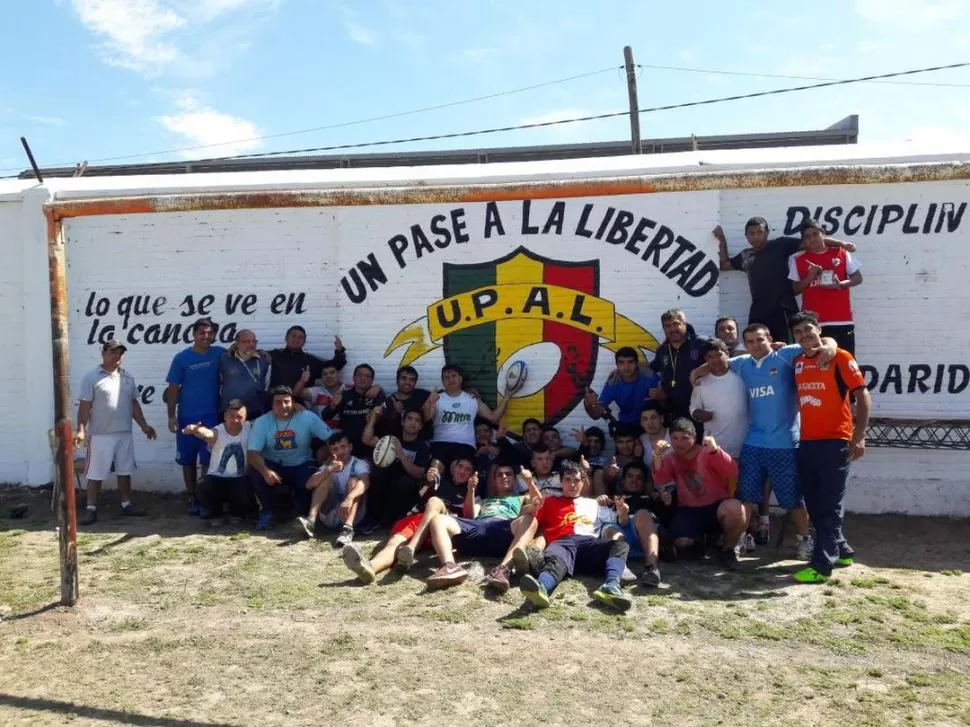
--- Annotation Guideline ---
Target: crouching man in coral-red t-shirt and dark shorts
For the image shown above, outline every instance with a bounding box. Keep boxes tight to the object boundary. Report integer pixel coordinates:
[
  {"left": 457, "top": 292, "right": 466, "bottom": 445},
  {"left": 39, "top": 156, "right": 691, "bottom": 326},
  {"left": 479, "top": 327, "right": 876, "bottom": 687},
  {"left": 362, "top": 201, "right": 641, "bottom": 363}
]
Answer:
[{"left": 653, "top": 417, "right": 748, "bottom": 570}]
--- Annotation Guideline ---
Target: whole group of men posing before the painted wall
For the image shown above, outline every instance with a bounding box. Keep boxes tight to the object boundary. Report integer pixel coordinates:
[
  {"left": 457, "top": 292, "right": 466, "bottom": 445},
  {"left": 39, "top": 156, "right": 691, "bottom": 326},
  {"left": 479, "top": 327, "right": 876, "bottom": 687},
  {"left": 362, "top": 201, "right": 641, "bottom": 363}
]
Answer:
[{"left": 77, "top": 213, "right": 870, "bottom": 610}]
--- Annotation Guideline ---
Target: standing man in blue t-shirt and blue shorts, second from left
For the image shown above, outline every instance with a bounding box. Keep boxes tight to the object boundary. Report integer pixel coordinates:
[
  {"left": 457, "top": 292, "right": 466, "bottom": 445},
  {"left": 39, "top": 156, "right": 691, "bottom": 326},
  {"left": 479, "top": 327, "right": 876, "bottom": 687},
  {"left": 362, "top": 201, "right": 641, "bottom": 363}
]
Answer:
[{"left": 165, "top": 318, "right": 226, "bottom": 515}]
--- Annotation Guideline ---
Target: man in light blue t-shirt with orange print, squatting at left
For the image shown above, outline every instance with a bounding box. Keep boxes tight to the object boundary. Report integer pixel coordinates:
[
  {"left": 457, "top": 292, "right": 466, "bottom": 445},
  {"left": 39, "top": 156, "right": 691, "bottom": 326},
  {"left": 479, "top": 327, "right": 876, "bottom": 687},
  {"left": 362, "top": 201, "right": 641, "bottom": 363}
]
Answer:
[{"left": 248, "top": 386, "right": 333, "bottom": 530}]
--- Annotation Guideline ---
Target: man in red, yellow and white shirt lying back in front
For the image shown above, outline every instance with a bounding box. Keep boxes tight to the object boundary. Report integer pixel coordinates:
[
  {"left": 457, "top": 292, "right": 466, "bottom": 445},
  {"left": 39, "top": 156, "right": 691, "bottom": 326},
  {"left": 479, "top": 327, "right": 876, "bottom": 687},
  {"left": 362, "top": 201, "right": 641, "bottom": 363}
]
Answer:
[{"left": 519, "top": 462, "right": 633, "bottom": 611}]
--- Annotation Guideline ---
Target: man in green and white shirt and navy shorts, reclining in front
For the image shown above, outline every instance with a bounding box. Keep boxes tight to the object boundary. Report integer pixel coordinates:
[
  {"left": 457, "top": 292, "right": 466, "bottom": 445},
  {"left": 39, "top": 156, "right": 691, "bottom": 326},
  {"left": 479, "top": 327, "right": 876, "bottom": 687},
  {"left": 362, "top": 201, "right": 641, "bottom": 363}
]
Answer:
[{"left": 428, "top": 464, "right": 536, "bottom": 593}]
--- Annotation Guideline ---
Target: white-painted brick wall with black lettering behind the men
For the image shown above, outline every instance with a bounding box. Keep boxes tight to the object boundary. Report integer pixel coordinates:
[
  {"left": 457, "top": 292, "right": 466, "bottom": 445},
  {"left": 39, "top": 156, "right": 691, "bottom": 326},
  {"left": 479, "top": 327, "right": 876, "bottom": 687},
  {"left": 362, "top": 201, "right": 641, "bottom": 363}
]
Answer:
[{"left": 0, "top": 153, "right": 970, "bottom": 515}]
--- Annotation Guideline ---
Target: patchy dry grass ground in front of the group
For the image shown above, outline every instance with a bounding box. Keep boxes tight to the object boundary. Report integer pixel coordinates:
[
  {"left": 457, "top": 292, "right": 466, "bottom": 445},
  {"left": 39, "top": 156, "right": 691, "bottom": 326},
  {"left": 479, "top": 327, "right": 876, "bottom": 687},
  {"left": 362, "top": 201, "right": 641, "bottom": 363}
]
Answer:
[{"left": 0, "top": 490, "right": 970, "bottom": 727}]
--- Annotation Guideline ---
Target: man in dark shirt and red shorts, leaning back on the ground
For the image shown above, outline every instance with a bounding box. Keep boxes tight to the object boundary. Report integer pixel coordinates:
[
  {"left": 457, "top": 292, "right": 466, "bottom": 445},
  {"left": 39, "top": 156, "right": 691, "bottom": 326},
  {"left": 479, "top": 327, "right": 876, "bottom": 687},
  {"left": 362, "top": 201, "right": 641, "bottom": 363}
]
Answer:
[{"left": 341, "top": 457, "right": 478, "bottom": 583}]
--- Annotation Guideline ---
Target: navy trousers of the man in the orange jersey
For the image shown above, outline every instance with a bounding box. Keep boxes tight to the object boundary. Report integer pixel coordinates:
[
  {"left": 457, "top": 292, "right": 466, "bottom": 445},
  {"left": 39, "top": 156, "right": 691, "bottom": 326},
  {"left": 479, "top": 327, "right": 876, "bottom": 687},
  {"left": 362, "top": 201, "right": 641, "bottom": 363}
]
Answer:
[{"left": 795, "top": 439, "right": 852, "bottom": 575}]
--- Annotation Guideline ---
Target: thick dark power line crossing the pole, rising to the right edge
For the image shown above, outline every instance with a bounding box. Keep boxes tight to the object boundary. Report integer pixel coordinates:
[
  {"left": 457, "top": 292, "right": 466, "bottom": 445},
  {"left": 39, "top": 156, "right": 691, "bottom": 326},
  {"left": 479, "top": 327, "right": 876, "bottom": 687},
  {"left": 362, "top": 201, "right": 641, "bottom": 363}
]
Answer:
[{"left": 142, "top": 61, "right": 970, "bottom": 163}]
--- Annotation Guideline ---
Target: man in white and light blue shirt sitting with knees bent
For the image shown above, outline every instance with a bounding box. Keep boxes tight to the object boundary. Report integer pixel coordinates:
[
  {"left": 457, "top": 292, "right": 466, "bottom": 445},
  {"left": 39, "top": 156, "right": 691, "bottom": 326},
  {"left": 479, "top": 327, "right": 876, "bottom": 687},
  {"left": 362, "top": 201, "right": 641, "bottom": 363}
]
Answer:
[{"left": 296, "top": 432, "right": 370, "bottom": 547}]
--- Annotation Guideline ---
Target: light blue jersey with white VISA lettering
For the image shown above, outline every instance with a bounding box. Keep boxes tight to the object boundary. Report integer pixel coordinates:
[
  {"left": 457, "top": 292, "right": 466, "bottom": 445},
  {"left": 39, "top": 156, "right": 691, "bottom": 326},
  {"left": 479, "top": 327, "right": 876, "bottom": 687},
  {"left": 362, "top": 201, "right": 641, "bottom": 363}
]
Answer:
[{"left": 728, "top": 345, "right": 802, "bottom": 449}]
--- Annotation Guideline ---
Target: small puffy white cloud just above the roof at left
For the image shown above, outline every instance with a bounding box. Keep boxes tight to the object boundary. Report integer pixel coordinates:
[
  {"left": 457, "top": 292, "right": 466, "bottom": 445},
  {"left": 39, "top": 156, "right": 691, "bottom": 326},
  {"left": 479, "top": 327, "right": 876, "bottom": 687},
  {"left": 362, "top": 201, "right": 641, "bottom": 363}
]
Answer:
[{"left": 156, "top": 93, "right": 260, "bottom": 159}]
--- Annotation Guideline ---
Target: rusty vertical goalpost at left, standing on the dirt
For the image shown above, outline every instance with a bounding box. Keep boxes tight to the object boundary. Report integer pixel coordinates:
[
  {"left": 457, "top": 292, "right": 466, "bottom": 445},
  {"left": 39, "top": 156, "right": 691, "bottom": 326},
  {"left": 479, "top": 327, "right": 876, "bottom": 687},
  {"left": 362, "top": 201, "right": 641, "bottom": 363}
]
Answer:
[{"left": 46, "top": 209, "right": 78, "bottom": 606}]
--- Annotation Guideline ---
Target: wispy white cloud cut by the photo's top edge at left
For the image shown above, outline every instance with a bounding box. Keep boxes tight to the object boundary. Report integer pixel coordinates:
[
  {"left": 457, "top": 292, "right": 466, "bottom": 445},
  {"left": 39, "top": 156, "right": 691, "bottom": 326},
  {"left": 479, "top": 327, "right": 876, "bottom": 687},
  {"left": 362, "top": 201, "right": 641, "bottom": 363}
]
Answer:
[{"left": 71, "top": 0, "right": 283, "bottom": 77}]
